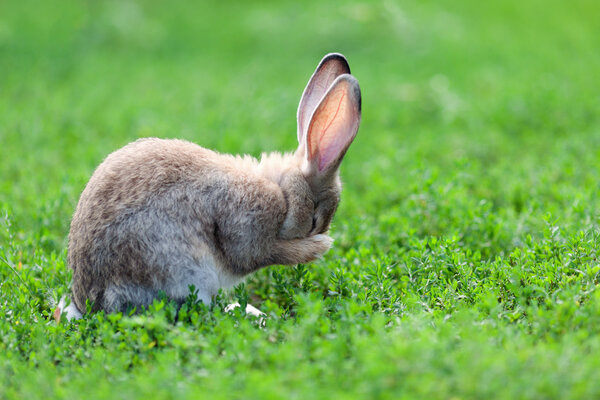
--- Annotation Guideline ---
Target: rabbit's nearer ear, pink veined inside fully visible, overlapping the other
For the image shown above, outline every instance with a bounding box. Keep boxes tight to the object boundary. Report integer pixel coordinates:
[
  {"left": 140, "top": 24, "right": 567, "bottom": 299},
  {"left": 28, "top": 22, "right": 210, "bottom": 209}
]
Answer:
[{"left": 306, "top": 74, "right": 361, "bottom": 175}]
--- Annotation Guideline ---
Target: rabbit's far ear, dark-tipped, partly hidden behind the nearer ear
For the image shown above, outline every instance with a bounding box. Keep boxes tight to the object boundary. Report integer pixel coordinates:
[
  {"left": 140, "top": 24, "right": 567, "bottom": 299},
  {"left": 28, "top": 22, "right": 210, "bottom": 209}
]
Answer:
[{"left": 297, "top": 53, "right": 350, "bottom": 146}]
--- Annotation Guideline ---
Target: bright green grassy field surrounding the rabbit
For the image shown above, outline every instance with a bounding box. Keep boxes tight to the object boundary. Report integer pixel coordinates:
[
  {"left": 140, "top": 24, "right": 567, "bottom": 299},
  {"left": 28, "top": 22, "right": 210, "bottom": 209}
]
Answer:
[{"left": 0, "top": 0, "right": 600, "bottom": 399}]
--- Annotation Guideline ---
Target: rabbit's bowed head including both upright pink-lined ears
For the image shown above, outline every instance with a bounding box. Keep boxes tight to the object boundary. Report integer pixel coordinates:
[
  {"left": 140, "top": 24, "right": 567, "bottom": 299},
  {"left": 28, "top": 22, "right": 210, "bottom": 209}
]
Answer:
[{"left": 264, "top": 53, "right": 361, "bottom": 239}]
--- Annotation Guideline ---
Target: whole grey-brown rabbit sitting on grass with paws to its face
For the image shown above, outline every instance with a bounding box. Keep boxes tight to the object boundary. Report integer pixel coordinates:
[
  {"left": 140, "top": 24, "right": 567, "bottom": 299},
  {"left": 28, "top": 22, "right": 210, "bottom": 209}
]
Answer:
[{"left": 59, "top": 53, "right": 361, "bottom": 319}]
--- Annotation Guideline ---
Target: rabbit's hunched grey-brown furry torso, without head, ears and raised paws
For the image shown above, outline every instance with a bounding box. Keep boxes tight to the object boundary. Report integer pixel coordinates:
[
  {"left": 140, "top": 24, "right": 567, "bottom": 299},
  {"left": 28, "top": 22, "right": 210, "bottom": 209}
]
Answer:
[{"left": 68, "top": 139, "right": 285, "bottom": 311}]
